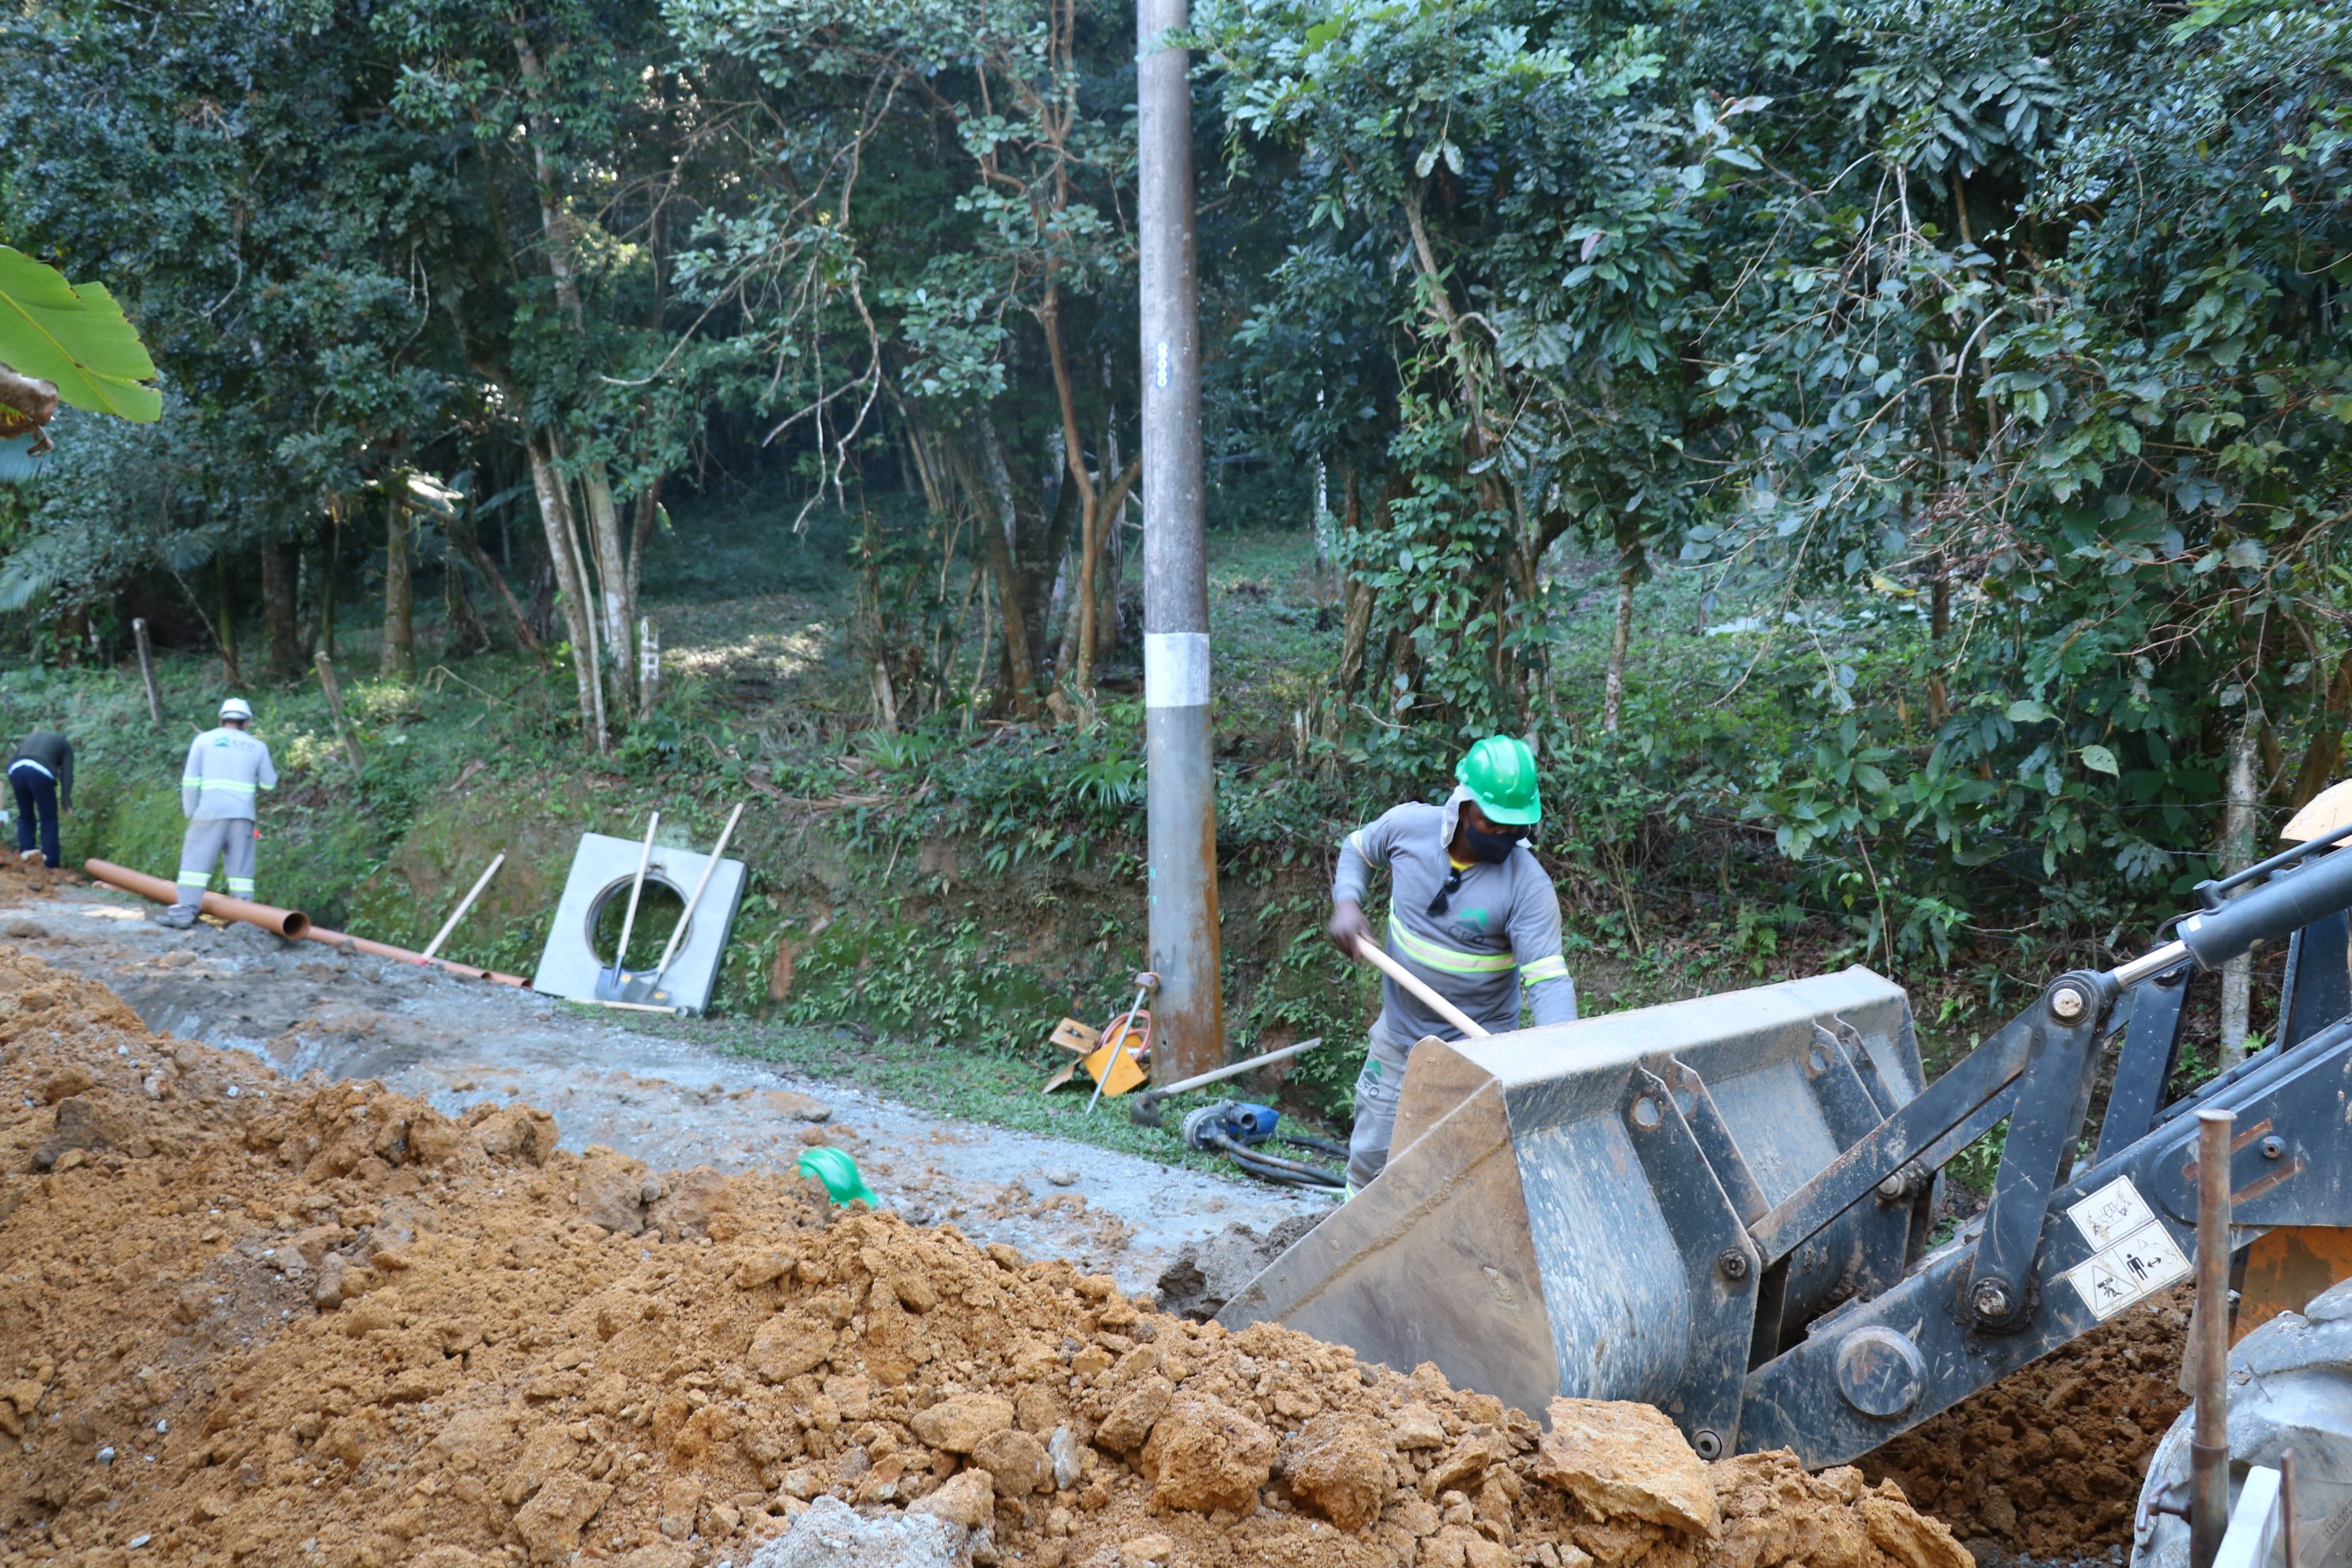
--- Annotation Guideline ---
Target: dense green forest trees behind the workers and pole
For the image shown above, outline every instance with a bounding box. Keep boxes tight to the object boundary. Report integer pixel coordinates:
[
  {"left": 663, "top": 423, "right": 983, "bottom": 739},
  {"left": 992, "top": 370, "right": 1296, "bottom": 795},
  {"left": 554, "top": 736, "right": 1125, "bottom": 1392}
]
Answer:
[{"left": 0, "top": 0, "right": 2352, "bottom": 962}]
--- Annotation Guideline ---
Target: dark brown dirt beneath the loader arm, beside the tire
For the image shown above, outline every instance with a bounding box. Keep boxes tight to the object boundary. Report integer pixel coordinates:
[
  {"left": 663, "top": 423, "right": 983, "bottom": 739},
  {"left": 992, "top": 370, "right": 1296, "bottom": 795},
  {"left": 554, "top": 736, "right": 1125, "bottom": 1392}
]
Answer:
[{"left": 1863, "top": 1288, "right": 2190, "bottom": 1559}]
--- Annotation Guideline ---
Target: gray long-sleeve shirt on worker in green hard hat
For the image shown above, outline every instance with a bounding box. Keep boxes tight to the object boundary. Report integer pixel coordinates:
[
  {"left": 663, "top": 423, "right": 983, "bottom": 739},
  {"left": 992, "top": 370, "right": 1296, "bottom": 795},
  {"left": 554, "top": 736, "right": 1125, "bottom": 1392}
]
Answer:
[{"left": 1331, "top": 790, "right": 1576, "bottom": 1049}]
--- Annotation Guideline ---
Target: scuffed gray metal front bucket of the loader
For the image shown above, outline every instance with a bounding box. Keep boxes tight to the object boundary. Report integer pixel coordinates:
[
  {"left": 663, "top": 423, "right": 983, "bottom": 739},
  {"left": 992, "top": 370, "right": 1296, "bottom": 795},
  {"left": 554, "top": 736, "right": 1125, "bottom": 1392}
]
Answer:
[{"left": 1219, "top": 968, "right": 1931, "bottom": 1457}]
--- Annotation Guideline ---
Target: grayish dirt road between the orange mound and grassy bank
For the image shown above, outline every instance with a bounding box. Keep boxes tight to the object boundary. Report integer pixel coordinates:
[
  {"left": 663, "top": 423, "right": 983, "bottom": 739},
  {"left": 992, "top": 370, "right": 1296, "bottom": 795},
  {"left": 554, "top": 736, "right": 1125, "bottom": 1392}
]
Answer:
[{"left": 0, "top": 881, "right": 1329, "bottom": 1291}]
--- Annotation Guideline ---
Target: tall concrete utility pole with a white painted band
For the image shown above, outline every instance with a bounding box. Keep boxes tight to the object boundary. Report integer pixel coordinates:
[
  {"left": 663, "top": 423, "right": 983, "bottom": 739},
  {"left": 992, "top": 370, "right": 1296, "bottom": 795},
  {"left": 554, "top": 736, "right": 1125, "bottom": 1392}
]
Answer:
[{"left": 1136, "top": 0, "right": 1225, "bottom": 1081}]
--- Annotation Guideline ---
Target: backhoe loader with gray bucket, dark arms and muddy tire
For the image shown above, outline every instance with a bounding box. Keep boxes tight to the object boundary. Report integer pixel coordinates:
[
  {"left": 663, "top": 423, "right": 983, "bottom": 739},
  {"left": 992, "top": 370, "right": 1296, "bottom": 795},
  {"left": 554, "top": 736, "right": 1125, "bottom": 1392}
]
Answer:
[{"left": 1219, "top": 783, "right": 2352, "bottom": 1568}]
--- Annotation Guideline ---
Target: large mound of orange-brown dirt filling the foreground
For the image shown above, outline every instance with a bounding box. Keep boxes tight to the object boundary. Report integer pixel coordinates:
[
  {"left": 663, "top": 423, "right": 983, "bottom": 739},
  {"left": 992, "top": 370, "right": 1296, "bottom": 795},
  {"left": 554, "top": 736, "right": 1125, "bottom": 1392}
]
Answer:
[{"left": 0, "top": 948, "right": 1969, "bottom": 1568}]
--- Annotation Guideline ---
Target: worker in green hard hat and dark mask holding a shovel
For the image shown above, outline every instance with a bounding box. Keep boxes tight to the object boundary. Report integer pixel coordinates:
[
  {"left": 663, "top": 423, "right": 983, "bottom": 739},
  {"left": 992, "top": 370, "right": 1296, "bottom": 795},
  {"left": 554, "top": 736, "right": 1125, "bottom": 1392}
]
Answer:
[{"left": 1329, "top": 736, "right": 1576, "bottom": 1194}]
